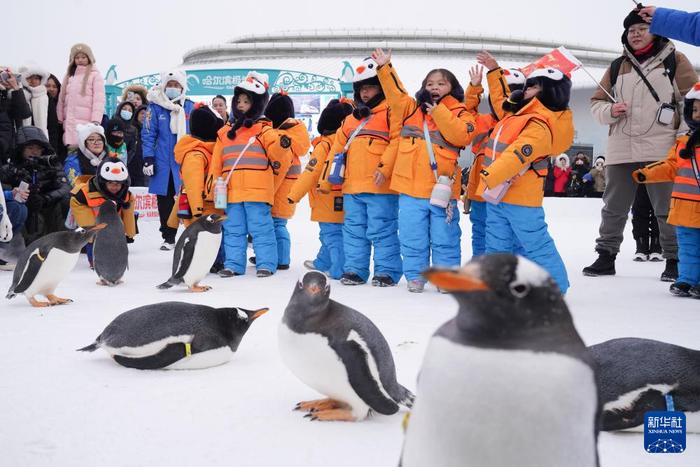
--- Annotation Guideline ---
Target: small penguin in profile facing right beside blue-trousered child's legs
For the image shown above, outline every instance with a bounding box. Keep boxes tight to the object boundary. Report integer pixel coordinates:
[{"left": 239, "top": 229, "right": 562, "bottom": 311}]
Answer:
[{"left": 157, "top": 214, "right": 226, "bottom": 292}]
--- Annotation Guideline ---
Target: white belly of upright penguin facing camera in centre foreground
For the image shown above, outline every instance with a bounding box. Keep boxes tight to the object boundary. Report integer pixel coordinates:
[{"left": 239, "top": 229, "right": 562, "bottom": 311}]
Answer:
[{"left": 278, "top": 323, "right": 369, "bottom": 420}]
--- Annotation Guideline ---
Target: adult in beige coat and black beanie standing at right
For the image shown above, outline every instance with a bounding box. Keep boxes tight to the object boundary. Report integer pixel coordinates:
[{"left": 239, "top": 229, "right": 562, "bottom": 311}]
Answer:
[{"left": 583, "top": 10, "right": 698, "bottom": 281}]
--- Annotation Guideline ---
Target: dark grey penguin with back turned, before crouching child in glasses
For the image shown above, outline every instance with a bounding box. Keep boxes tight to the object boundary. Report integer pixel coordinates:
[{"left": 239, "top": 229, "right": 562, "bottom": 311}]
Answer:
[{"left": 92, "top": 200, "right": 129, "bottom": 286}]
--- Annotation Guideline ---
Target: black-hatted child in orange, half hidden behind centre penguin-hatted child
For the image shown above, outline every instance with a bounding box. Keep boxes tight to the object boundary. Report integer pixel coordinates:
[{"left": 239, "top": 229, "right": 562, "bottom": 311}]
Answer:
[{"left": 288, "top": 99, "right": 352, "bottom": 279}]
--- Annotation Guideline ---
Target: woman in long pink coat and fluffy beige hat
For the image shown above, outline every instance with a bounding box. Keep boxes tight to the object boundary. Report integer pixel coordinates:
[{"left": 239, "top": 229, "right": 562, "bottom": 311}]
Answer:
[{"left": 56, "top": 44, "right": 105, "bottom": 147}]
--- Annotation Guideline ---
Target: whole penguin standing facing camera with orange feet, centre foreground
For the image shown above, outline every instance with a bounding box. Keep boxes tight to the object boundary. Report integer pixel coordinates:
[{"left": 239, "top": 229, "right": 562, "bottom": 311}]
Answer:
[{"left": 279, "top": 271, "right": 413, "bottom": 421}]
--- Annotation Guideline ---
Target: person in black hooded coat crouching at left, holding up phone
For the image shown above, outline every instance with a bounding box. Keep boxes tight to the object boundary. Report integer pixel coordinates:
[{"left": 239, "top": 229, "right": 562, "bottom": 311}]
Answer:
[{"left": 0, "top": 126, "right": 70, "bottom": 245}]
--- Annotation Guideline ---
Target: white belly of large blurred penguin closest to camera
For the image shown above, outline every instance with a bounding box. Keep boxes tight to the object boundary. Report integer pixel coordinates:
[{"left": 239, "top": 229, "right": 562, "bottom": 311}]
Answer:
[{"left": 402, "top": 337, "right": 597, "bottom": 467}]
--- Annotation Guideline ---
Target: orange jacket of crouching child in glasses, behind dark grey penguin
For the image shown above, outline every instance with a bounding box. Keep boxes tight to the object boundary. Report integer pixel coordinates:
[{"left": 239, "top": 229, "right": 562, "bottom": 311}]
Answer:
[{"left": 70, "top": 176, "right": 136, "bottom": 238}]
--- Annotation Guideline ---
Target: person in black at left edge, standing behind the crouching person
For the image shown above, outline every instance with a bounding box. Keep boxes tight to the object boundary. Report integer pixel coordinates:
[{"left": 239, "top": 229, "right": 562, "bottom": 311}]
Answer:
[{"left": 0, "top": 66, "right": 32, "bottom": 163}]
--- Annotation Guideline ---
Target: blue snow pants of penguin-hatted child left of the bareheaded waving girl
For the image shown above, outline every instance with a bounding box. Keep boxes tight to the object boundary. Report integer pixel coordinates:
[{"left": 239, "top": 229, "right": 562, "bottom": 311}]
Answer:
[{"left": 343, "top": 193, "right": 403, "bottom": 282}]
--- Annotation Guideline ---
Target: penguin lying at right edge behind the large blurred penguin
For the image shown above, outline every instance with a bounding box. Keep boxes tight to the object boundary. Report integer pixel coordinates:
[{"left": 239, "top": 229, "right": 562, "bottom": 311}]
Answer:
[{"left": 589, "top": 337, "right": 700, "bottom": 433}]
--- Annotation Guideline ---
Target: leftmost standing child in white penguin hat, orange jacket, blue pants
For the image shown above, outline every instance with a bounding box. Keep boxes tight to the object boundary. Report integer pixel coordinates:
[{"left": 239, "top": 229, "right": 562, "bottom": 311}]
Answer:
[{"left": 206, "top": 71, "right": 292, "bottom": 277}]
